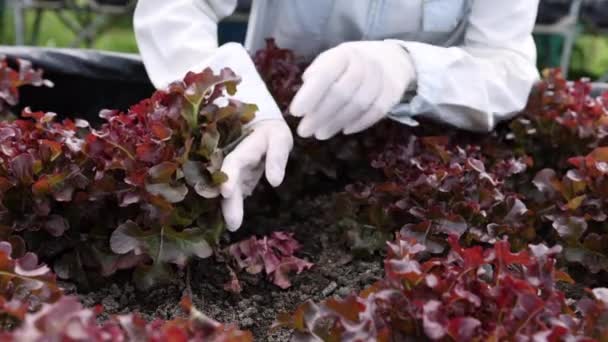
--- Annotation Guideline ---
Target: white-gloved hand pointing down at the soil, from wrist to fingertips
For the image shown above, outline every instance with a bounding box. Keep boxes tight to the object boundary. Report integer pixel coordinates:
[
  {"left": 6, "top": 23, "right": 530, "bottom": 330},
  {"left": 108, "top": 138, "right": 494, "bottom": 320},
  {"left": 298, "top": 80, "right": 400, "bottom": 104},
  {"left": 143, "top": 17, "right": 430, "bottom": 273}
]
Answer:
[{"left": 220, "top": 118, "right": 293, "bottom": 231}]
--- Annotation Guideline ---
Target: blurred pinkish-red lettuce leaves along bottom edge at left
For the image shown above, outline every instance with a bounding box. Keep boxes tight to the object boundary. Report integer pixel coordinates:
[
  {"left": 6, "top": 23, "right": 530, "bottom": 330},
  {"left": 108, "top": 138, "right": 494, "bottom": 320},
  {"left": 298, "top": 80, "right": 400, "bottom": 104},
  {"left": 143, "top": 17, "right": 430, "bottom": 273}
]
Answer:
[{"left": 0, "top": 296, "right": 253, "bottom": 342}]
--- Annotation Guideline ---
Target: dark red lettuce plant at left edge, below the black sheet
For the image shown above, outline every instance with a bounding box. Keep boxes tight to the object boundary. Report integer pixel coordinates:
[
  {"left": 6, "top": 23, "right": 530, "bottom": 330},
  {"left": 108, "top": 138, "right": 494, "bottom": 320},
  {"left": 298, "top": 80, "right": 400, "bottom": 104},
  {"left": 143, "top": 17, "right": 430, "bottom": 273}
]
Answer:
[{"left": 0, "top": 109, "right": 93, "bottom": 236}]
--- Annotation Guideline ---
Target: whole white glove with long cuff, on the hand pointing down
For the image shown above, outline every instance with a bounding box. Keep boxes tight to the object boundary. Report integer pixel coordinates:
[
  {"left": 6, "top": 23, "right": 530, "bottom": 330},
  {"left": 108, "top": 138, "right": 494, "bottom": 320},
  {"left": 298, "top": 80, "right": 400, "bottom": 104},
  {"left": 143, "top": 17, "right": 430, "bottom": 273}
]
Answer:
[{"left": 191, "top": 43, "right": 293, "bottom": 231}]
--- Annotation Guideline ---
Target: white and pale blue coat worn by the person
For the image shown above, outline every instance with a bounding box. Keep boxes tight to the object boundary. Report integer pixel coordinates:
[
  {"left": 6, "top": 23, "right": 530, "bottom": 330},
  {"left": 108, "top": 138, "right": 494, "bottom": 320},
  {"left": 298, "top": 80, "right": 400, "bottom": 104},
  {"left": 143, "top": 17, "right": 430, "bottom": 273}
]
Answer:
[{"left": 134, "top": 0, "right": 539, "bottom": 131}]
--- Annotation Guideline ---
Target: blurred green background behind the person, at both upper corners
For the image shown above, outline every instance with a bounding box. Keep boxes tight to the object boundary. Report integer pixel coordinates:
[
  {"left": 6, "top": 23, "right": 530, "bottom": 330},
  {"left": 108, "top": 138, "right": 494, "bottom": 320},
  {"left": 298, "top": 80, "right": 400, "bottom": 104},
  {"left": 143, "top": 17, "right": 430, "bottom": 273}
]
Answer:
[{"left": 0, "top": 0, "right": 608, "bottom": 81}]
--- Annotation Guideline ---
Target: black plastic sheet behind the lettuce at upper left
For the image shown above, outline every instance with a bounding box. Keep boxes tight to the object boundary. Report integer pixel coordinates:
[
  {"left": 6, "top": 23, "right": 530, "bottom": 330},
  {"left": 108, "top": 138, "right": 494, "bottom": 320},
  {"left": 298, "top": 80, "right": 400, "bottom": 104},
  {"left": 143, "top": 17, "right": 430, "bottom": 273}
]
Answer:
[{"left": 0, "top": 46, "right": 154, "bottom": 123}]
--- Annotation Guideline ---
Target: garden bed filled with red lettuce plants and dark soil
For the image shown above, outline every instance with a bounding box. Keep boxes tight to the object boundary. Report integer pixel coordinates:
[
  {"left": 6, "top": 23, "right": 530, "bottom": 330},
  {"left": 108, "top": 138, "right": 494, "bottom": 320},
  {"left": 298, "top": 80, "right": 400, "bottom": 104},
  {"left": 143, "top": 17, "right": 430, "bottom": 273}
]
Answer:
[{"left": 0, "top": 41, "right": 608, "bottom": 342}]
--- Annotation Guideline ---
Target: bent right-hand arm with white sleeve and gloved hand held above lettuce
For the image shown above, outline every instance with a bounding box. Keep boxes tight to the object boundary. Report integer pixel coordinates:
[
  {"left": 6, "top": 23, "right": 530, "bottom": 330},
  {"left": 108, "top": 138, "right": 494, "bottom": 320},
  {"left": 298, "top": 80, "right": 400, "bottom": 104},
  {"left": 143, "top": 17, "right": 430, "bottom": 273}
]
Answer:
[{"left": 290, "top": 0, "right": 538, "bottom": 140}]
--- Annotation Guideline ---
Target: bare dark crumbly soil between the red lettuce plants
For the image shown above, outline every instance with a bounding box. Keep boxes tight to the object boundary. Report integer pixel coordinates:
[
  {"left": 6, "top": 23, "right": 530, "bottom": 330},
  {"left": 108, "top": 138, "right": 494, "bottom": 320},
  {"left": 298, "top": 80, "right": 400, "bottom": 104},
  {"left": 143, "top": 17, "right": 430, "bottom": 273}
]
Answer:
[{"left": 73, "top": 191, "right": 383, "bottom": 341}]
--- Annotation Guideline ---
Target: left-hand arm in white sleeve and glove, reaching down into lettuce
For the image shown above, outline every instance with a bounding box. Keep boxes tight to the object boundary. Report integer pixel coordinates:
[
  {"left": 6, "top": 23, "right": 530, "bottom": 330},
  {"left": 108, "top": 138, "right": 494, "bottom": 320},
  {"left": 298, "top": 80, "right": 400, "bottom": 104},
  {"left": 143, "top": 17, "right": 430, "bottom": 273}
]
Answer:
[{"left": 133, "top": 0, "right": 293, "bottom": 230}]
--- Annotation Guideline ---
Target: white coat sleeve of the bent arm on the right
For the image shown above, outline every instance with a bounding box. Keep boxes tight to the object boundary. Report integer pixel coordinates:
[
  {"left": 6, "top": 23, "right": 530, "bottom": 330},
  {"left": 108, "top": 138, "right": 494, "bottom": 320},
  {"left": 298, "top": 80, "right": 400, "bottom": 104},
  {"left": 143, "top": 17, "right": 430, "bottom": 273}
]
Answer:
[{"left": 390, "top": 0, "right": 538, "bottom": 132}]
